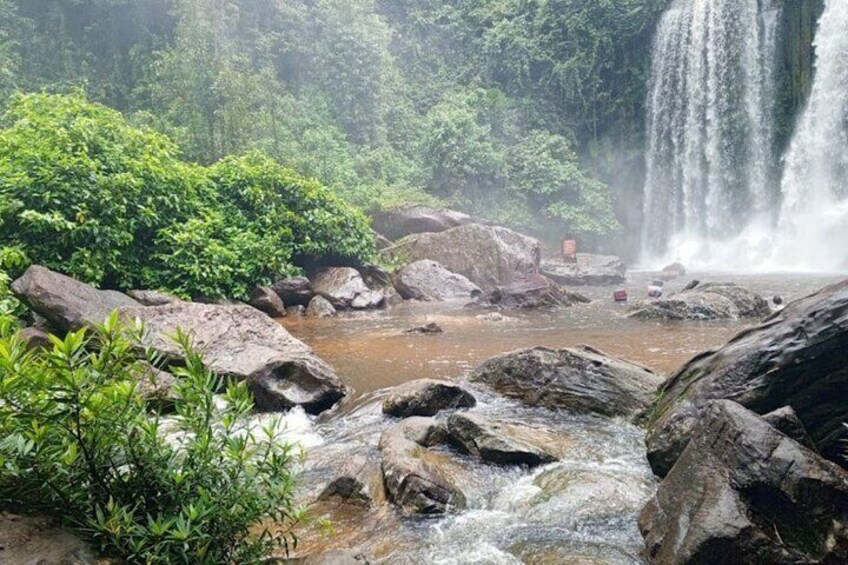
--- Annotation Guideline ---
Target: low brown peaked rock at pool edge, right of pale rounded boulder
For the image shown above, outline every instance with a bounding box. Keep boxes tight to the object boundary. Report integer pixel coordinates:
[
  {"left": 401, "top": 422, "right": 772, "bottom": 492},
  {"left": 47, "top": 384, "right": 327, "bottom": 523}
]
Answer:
[{"left": 470, "top": 274, "right": 590, "bottom": 310}]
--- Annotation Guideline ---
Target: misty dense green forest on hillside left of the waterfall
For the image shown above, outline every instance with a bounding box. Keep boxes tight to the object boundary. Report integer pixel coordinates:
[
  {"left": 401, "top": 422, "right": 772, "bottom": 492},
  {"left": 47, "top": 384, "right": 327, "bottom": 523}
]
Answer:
[{"left": 0, "top": 0, "right": 667, "bottom": 242}]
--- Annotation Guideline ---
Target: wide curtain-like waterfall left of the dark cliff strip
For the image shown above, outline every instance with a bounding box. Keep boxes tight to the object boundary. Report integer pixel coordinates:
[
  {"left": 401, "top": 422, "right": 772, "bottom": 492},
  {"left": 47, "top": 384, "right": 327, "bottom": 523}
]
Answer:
[{"left": 643, "top": 0, "right": 780, "bottom": 263}]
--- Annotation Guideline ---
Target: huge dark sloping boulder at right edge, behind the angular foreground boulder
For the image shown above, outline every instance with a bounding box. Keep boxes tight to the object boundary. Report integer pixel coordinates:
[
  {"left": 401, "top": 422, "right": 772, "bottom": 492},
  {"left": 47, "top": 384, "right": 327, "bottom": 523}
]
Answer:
[{"left": 646, "top": 280, "right": 848, "bottom": 476}]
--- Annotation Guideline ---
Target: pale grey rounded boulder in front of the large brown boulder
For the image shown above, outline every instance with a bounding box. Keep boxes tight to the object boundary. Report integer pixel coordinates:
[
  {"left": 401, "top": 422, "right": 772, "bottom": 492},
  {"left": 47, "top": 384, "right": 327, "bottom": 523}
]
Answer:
[{"left": 393, "top": 259, "right": 482, "bottom": 301}]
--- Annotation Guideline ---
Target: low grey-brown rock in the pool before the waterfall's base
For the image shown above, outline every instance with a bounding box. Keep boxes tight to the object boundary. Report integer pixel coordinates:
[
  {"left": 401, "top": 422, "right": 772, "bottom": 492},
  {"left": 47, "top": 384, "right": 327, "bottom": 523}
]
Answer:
[{"left": 628, "top": 283, "right": 771, "bottom": 320}]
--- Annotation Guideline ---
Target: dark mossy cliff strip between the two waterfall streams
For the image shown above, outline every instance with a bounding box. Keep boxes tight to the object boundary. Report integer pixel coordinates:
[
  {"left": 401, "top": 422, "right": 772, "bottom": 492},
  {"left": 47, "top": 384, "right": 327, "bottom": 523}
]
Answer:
[{"left": 774, "top": 0, "right": 825, "bottom": 154}]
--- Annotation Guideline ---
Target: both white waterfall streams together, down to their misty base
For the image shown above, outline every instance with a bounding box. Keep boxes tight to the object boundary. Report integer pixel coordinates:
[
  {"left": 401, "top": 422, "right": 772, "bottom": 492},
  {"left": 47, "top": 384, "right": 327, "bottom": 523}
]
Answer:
[{"left": 644, "top": 0, "right": 848, "bottom": 272}]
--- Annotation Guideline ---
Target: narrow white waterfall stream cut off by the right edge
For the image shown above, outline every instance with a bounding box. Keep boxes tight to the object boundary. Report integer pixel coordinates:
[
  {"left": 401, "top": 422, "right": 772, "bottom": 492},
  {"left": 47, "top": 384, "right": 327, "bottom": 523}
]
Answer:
[{"left": 770, "top": 0, "right": 848, "bottom": 270}]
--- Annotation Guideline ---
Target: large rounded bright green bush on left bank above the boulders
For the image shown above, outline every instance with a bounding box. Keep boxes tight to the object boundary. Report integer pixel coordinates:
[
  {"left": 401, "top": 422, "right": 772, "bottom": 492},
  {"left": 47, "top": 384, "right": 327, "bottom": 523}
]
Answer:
[{"left": 0, "top": 93, "right": 373, "bottom": 298}]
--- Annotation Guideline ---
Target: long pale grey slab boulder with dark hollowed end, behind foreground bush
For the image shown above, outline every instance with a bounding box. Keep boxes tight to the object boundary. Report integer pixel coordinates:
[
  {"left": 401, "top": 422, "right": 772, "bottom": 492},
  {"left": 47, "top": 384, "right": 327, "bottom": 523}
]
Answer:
[{"left": 124, "top": 302, "right": 347, "bottom": 414}]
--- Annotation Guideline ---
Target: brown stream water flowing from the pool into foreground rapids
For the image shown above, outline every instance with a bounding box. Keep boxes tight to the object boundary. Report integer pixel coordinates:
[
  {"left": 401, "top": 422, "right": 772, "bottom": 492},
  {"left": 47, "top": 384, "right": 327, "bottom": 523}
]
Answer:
[{"left": 268, "top": 273, "right": 837, "bottom": 565}]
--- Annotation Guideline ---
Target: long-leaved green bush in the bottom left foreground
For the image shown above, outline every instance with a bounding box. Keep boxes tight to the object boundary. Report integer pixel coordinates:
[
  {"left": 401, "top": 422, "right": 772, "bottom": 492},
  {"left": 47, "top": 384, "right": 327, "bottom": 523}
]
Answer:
[{"left": 0, "top": 315, "right": 300, "bottom": 564}]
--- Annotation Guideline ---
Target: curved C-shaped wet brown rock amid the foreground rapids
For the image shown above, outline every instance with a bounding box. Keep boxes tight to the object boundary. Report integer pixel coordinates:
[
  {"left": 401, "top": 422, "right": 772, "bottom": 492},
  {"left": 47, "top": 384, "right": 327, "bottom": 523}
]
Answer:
[{"left": 379, "top": 417, "right": 465, "bottom": 514}]
